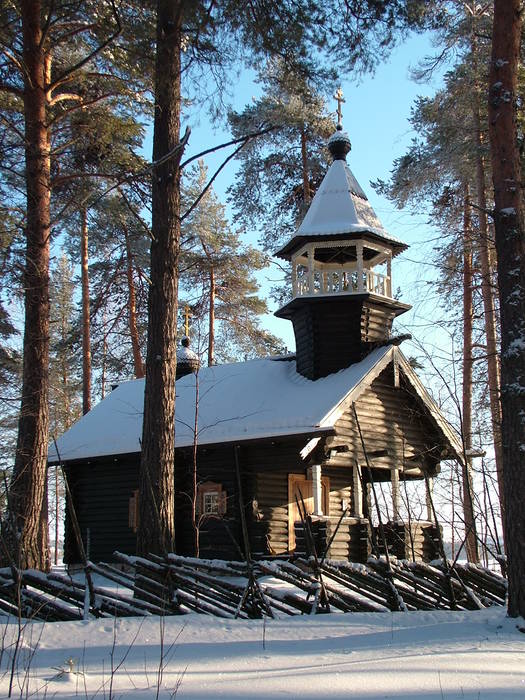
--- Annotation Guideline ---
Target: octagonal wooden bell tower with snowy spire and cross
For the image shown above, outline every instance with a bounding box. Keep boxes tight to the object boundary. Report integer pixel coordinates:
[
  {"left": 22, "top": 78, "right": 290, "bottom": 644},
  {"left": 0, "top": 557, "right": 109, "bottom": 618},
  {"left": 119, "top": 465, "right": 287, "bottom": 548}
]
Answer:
[{"left": 275, "top": 90, "right": 410, "bottom": 379}]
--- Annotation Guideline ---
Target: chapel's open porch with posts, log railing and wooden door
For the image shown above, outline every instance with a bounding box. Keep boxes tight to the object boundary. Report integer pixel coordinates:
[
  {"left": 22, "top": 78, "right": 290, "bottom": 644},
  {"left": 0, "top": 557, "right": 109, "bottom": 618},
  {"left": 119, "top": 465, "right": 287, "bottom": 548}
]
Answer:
[{"left": 288, "top": 464, "right": 440, "bottom": 563}]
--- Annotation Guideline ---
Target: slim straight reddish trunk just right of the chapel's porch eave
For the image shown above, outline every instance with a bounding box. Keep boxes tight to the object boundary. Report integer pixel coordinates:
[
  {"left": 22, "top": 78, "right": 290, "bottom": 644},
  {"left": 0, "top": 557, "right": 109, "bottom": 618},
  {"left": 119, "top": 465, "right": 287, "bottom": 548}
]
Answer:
[{"left": 462, "top": 185, "right": 479, "bottom": 563}]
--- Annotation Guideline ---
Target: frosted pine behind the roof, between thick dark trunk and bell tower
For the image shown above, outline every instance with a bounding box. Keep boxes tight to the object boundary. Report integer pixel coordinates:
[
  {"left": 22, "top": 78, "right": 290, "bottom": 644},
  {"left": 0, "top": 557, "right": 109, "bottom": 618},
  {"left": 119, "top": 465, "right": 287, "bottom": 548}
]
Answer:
[{"left": 180, "top": 161, "right": 282, "bottom": 365}]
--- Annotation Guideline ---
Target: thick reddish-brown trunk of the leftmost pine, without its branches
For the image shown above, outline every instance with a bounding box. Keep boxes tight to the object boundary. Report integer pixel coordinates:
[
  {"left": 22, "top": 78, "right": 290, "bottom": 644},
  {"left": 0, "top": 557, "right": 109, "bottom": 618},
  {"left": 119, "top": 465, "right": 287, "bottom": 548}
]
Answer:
[{"left": 9, "top": 0, "right": 51, "bottom": 569}]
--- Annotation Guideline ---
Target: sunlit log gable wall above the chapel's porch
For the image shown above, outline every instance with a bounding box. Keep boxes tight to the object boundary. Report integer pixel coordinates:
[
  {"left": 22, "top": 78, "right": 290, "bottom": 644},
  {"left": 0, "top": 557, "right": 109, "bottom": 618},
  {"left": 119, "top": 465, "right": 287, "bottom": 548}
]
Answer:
[{"left": 327, "top": 363, "right": 447, "bottom": 477}]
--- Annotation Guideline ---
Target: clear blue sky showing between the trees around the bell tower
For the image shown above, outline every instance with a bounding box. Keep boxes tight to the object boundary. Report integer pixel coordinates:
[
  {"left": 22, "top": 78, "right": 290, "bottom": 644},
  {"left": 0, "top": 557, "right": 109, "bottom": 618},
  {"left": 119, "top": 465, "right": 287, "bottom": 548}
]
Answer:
[{"left": 166, "top": 30, "right": 448, "bottom": 350}]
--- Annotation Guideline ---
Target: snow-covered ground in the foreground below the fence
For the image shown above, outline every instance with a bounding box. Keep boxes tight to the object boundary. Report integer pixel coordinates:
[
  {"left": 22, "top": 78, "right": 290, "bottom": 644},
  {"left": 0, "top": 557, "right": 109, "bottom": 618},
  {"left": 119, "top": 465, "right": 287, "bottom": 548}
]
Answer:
[{"left": 0, "top": 608, "right": 525, "bottom": 700}]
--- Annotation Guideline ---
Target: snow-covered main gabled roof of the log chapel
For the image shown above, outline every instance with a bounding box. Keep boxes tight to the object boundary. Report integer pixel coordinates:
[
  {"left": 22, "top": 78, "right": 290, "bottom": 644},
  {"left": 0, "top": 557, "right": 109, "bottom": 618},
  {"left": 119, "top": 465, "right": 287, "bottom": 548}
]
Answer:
[{"left": 49, "top": 346, "right": 456, "bottom": 462}]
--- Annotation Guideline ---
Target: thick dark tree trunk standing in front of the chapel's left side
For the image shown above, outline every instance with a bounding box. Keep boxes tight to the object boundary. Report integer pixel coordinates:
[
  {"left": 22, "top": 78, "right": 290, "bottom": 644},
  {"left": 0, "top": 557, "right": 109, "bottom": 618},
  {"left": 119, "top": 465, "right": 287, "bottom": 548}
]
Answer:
[{"left": 137, "top": 0, "right": 184, "bottom": 554}]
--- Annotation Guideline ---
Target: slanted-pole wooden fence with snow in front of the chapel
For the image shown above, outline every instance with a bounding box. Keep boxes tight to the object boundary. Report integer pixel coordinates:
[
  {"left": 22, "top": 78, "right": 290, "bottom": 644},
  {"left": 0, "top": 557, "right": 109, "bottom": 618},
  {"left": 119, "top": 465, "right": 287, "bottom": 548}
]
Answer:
[{"left": 0, "top": 553, "right": 507, "bottom": 621}]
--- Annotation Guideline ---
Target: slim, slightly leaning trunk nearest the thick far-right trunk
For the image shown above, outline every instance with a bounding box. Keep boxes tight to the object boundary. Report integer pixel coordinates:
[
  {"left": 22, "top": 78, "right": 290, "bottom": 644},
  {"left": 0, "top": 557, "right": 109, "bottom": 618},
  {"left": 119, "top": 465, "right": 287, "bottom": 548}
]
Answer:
[{"left": 471, "top": 15, "right": 505, "bottom": 532}]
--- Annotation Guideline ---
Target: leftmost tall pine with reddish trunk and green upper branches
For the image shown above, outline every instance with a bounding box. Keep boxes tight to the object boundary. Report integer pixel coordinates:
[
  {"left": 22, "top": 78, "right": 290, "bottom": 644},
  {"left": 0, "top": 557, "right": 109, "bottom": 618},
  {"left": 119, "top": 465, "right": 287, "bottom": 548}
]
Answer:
[{"left": 0, "top": 0, "right": 154, "bottom": 568}]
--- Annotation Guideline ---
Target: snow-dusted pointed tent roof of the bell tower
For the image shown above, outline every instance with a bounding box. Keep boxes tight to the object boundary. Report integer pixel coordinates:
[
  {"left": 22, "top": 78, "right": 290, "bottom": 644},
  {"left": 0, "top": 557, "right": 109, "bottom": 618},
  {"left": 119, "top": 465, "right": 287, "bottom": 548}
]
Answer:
[{"left": 276, "top": 160, "right": 408, "bottom": 257}]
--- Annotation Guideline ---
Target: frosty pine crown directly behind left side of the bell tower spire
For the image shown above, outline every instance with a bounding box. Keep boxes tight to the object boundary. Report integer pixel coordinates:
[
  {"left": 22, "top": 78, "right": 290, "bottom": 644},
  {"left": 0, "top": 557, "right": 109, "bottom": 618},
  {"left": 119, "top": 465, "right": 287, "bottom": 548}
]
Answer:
[{"left": 228, "top": 59, "right": 335, "bottom": 252}]
